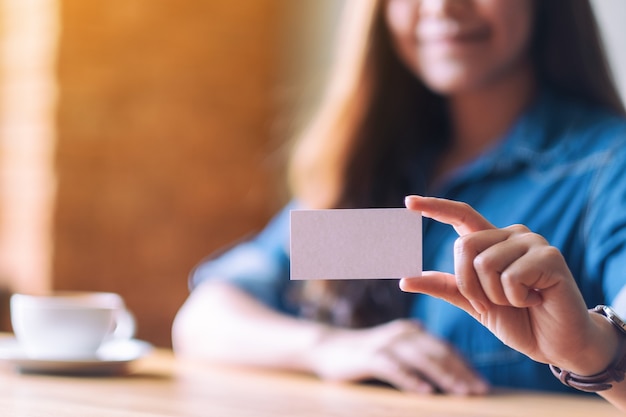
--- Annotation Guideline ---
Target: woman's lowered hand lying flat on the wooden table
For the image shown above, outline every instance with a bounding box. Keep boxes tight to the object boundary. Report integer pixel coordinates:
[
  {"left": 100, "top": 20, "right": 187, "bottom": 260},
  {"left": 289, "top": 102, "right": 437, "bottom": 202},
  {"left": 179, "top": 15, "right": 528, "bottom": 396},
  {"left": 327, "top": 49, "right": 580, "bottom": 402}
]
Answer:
[{"left": 311, "top": 320, "right": 489, "bottom": 395}]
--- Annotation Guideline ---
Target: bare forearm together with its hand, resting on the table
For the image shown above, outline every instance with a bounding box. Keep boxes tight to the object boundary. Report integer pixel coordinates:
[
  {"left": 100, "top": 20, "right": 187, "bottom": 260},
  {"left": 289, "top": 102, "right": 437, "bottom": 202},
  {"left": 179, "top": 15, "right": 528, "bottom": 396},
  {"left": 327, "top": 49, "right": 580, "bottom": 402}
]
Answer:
[{"left": 173, "top": 282, "right": 488, "bottom": 395}]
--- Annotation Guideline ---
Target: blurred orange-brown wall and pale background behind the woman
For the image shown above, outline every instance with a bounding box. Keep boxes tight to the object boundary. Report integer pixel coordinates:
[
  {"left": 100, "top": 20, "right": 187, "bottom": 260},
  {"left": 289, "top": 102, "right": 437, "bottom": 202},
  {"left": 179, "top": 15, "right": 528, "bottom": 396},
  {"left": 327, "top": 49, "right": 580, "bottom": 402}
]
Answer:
[{"left": 0, "top": 0, "right": 626, "bottom": 346}]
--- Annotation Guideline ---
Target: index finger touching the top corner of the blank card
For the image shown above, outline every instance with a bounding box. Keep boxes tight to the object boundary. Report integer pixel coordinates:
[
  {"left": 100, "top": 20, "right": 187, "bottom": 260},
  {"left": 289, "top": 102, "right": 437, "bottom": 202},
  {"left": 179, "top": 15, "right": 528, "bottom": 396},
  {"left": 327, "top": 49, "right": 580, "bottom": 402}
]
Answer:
[{"left": 404, "top": 195, "right": 495, "bottom": 236}]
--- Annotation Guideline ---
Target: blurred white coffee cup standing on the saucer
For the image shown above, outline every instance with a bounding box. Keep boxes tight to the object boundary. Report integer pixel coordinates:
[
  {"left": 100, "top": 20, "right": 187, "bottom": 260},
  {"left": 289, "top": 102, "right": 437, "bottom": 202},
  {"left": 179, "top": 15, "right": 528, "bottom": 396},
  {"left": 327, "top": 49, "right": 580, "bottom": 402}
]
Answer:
[{"left": 11, "top": 292, "right": 135, "bottom": 360}]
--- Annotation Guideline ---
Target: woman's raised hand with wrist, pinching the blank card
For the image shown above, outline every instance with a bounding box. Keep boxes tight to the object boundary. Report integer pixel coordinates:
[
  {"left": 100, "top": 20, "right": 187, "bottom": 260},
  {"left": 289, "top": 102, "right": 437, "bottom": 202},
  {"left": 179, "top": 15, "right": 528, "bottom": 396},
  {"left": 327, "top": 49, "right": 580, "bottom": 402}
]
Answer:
[{"left": 400, "top": 196, "right": 606, "bottom": 371}]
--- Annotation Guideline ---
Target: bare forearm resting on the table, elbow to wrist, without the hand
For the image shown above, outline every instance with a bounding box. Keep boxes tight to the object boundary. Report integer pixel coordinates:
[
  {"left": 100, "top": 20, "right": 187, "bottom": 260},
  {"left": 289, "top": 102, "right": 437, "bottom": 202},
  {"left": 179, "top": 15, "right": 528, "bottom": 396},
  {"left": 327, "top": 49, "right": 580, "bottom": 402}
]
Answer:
[{"left": 172, "top": 282, "right": 327, "bottom": 372}]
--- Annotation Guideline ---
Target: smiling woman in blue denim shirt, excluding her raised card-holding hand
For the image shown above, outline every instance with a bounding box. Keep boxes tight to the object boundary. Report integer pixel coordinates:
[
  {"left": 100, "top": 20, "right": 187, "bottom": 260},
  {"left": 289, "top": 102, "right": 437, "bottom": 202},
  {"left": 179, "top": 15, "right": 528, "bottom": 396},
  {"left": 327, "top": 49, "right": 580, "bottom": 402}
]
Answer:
[{"left": 173, "top": 0, "right": 626, "bottom": 406}]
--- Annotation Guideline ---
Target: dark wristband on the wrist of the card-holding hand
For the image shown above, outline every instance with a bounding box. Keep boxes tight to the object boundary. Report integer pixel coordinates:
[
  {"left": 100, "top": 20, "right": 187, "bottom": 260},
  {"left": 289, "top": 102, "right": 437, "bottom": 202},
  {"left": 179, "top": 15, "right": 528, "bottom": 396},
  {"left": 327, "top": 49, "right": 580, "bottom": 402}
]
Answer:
[{"left": 550, "top": 305, "right": 626, "bottom": 392}]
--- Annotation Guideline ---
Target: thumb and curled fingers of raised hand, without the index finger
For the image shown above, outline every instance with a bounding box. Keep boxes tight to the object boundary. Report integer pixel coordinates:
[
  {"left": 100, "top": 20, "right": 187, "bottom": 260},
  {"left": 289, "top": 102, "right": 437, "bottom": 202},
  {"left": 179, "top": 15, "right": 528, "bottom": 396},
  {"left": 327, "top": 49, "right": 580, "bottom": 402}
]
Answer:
[{"left": 400, "top": 225, "right": 568, "bottom": 310}]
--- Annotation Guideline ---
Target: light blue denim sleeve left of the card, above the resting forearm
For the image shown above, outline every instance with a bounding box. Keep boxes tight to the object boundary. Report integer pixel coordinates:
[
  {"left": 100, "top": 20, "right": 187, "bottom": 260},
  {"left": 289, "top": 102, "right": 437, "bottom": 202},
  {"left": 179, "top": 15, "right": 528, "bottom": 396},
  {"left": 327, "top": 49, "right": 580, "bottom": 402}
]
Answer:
[{"left": 189, "top": 202, "right": 296, "bottom": 311}]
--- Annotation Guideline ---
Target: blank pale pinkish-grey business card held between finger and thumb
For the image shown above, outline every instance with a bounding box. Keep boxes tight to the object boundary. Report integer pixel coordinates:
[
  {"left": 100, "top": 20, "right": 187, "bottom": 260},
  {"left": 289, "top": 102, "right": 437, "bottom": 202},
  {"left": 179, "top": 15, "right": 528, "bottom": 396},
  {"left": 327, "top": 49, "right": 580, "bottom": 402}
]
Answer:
[{"left": 290, "top": 208, "right": 422, "bottom": 280}]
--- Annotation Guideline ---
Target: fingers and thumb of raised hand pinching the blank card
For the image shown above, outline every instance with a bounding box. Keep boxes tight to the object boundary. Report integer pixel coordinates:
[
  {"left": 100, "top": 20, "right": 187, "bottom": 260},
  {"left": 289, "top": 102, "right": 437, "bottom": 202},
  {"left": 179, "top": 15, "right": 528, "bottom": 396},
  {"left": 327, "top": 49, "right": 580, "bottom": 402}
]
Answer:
[{"left": 404, "top": 196, "right": 555, "bottom": 308}]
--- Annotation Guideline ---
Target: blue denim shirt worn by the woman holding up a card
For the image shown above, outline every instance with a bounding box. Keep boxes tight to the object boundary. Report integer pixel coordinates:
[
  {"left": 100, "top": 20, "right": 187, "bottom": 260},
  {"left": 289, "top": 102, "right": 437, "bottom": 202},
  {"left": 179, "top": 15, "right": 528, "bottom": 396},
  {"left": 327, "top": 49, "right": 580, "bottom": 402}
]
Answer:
[{"left": 191, "top": 92, "right": 626, "bottom": 391}]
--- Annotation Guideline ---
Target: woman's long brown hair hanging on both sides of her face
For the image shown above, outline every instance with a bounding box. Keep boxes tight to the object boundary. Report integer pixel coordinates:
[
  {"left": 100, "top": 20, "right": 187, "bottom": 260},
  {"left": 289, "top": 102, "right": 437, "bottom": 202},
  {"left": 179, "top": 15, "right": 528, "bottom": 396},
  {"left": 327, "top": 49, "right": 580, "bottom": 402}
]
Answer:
[{"left": 292, "top": 0, "right": 625, "bottom": 327}]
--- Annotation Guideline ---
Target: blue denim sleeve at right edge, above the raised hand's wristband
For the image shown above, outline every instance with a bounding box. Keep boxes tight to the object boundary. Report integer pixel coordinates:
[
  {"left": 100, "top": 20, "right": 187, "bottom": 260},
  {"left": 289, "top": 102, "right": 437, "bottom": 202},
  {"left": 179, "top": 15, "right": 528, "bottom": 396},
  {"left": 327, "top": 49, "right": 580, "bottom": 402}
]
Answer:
[{"left": 585, "top": 125, "right": 626, "bottom": 308}]
